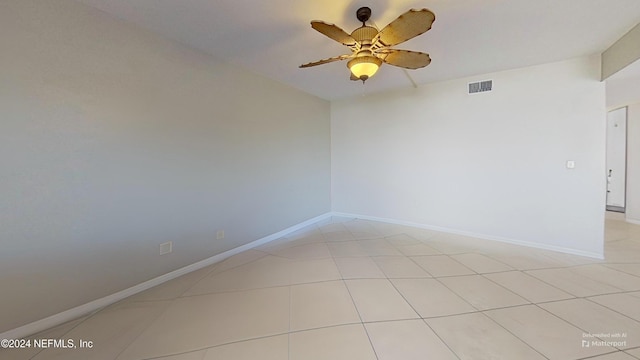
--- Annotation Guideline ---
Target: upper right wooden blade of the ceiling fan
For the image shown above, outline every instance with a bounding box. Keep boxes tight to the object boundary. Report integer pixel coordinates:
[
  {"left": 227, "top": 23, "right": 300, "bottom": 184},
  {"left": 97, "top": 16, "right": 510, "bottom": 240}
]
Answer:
[{"left": 372, "top": 9, "right": 436, "bottom": 47}]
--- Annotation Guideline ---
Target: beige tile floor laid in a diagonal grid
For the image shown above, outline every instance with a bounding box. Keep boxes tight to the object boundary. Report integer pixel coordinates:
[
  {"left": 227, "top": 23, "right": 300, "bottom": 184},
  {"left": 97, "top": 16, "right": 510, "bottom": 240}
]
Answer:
[{"left": 5, "top": 216, "right": 640, "bottom": 360}]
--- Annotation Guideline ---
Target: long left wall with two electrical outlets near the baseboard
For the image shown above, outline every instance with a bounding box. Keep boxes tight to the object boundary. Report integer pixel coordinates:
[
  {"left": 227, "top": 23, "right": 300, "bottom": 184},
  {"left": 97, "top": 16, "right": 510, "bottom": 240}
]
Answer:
[{"left": 0, "top": 0, "right": 330, "bottom": 332}]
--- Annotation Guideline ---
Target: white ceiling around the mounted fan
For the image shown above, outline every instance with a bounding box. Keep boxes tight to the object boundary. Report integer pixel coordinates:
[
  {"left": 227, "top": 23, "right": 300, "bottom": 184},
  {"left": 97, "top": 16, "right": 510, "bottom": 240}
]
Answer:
[{"left": 78, "top": 0, "right": 640, "bottom": 100}]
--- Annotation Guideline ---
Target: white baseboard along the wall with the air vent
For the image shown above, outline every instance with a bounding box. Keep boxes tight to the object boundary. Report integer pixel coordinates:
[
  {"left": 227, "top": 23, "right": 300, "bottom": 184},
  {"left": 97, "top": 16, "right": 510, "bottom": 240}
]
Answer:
[{"left": 332, "top": 212, "right": 604, "bottom": 260}]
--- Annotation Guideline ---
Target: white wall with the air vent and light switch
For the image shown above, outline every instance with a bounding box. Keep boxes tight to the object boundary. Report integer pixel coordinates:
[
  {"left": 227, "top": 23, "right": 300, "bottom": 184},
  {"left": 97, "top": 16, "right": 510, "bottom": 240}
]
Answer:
[{"left": 331, "top": 56, "right": 606, "bottom": 256}]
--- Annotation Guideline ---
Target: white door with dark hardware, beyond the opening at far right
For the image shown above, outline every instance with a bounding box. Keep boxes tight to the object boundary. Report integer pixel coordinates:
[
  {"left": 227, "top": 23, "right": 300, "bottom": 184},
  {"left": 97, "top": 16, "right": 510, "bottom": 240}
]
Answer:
[{"left": 607, "top": 107, "right": 627, "bottom": 212}]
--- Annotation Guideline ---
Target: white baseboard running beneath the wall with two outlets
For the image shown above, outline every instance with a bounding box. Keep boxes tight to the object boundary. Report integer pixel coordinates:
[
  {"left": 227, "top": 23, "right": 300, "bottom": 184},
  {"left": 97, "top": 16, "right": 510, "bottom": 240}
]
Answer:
[{"left": 0, "top": 213, "right": 332, "bottom": 339}]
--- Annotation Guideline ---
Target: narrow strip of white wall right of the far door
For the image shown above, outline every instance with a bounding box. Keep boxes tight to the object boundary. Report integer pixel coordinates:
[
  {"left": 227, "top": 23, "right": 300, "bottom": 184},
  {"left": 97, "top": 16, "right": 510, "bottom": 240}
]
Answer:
[{"left": 625, "top": 103, "right": 640, "bottom": 224}]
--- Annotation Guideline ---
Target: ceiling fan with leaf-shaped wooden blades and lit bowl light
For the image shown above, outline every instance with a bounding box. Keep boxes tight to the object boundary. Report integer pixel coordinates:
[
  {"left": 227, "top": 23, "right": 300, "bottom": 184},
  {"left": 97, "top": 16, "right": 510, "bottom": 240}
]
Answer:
[{"left": 300, "top": 7, "right": 436, "bottom": 83}]
